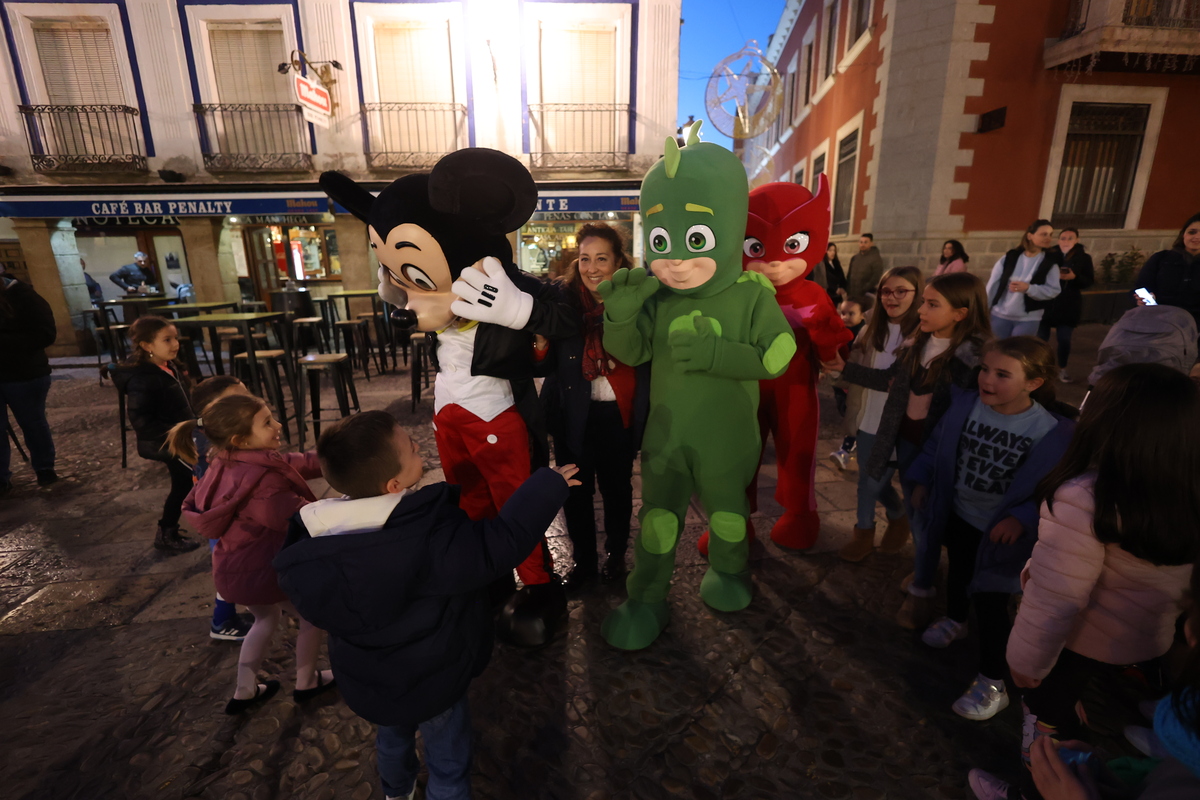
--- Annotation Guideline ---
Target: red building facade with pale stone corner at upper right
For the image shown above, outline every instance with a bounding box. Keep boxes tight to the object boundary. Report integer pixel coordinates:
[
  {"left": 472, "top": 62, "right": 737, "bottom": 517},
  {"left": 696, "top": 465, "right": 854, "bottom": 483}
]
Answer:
[{"left": 743, "top": 0, "right": 1200, "bottom": 278}]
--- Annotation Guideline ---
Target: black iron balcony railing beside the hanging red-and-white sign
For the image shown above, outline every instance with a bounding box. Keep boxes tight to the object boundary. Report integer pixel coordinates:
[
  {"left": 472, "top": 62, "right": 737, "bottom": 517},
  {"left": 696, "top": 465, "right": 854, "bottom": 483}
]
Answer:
[{"left": 193, "top": 103, "right": 312, "bottom": 173}]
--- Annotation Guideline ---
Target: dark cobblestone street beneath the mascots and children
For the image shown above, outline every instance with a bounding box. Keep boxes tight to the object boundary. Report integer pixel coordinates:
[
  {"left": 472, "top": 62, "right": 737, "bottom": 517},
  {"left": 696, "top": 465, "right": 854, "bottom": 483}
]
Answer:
[{"left": 0, "top": 325, "right": 1105, "bottom": 800}]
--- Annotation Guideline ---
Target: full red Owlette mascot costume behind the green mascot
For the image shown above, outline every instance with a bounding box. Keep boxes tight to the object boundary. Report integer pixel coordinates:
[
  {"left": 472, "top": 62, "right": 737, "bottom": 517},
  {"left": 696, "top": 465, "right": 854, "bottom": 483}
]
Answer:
[{"left": 742, "top": 175, "right": 854, "bottom": 549}]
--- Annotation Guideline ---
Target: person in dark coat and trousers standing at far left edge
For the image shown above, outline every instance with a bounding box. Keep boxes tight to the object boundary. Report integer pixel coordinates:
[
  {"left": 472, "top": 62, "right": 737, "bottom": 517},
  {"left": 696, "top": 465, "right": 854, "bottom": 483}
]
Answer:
[{"left": 0, "top": 275, "right": 59, "bottom": 495}]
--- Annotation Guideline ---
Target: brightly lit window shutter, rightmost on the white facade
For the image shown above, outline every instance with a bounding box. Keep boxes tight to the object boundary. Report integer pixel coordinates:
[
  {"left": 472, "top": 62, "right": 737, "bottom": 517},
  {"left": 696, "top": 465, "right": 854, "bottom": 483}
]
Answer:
[{"left": 540, "top": 23, "right": 617, "bottom": 104}]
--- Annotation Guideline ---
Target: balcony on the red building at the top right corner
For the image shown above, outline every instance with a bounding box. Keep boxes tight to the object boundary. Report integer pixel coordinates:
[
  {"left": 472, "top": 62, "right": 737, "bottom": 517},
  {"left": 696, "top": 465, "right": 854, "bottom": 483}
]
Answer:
[{"left": 1044, "top": 0, "right": 1200, "bottom": 74}]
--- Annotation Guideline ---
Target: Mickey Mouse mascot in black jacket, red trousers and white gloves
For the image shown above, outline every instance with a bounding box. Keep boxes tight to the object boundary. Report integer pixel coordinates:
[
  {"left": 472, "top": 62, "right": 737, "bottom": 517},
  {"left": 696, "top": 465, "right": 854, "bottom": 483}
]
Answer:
[{"left": 320, "top": 148, "right": 578, "bottom": 646}]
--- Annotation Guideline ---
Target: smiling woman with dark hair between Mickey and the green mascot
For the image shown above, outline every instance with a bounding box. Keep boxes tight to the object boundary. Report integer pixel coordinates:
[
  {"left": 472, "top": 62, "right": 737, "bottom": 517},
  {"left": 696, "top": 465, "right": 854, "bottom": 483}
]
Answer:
[{"left": 538, "top": 222, "right": 650, "bottom": 590}]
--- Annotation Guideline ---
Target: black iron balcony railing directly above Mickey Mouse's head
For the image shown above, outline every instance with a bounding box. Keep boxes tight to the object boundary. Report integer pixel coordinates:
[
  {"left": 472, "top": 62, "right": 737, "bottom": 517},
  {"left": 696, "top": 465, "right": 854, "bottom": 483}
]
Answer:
[{"left": 362, "top": 103, "right": 467, "bottom": 170}]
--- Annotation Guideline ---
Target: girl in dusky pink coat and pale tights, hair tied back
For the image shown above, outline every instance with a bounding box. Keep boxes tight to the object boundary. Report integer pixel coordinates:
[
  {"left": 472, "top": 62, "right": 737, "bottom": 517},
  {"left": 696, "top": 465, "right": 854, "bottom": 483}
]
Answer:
[{"left": 169, "top": 395, "right": 334, "bottom": 714}]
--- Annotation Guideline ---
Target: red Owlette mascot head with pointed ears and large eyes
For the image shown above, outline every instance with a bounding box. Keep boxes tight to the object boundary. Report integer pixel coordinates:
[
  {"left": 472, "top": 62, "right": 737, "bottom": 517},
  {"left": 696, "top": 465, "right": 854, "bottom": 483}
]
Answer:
[{"left": 742, "top": 174, "right": 829, "bottom": 287}]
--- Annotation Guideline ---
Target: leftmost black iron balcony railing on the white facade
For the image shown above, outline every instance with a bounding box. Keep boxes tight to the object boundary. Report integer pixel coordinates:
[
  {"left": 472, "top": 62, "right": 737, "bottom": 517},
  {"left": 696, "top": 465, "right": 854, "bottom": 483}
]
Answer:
[{"left": 17, "top": 106, "right": 146, "bottom": 173}]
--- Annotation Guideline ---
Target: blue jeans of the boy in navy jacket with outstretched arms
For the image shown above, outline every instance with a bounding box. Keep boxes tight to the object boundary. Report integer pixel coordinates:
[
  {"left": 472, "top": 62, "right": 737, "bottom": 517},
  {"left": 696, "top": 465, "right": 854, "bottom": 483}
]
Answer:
[{"left": 376, "top": 694, "right": 472, "bottom": 800}]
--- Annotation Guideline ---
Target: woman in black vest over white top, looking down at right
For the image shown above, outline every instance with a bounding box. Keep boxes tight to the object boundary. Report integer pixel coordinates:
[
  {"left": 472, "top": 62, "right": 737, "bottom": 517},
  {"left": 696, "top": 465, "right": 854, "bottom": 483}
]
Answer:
[{"left": 988, "top": 219, "right": 1062, "bottom": 339}]
